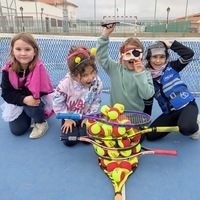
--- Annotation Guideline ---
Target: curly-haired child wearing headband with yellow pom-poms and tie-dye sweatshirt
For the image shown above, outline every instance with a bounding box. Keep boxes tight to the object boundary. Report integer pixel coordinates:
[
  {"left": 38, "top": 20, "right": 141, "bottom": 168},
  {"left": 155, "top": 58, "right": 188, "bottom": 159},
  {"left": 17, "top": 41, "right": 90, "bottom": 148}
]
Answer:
[{"left": 53, "top": 46, "right": 102, "bottom": 146}]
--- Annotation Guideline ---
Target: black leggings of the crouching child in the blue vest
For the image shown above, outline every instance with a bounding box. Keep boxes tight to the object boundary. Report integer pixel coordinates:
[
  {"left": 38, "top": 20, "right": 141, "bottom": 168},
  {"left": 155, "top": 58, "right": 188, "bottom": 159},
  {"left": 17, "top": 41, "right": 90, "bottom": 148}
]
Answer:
[{"left": 146, "top": 101, "right": 199, "bottom": 141}]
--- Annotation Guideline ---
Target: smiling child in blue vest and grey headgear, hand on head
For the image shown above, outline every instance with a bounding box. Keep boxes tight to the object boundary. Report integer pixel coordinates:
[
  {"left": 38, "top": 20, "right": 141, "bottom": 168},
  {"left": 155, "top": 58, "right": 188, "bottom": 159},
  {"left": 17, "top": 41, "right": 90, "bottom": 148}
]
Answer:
[{"left": 143, "top": 40, "right": 200, "bottom": 141}]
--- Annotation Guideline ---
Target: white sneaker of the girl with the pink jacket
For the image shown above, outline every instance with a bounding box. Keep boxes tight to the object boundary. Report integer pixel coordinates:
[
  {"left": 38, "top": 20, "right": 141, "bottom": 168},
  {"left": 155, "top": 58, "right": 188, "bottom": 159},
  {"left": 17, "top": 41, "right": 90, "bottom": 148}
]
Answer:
[{"left": 29, "top": 122, "right": 49, "bottom": 138}]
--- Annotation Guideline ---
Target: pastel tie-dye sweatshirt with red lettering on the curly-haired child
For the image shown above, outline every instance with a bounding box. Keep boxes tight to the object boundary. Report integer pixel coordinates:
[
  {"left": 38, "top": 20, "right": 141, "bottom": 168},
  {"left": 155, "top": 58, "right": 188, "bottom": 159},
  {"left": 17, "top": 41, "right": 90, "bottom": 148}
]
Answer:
[{"left": 53, "top": 73, "right": 103, "bottom": 114}]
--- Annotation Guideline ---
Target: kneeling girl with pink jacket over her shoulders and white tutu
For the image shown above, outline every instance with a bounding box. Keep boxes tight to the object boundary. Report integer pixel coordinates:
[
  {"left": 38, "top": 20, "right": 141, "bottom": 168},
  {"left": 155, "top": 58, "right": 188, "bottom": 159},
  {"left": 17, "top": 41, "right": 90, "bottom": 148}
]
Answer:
[{"left": 1, "top": 33, "right": 53, "bottom": 138}]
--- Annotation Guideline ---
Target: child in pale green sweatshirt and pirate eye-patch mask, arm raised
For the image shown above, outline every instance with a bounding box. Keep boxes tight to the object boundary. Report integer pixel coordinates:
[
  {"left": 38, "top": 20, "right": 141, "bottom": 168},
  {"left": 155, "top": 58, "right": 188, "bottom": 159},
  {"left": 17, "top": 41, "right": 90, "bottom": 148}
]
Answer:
[{"left": 96, "top": 23, "right": 154, "bottom": 118}]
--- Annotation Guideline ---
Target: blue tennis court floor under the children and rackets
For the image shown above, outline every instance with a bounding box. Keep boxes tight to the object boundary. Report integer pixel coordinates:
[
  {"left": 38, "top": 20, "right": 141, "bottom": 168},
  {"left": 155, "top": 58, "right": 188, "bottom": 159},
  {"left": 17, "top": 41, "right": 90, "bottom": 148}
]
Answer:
[{"left": 0, "top": 94, "right": 200, "bottom": 200}]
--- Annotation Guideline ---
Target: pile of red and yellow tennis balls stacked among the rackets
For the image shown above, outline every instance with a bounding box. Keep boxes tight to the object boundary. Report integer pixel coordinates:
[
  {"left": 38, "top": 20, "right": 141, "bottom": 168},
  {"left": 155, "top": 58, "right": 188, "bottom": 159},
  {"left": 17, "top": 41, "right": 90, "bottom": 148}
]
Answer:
[{"left": 86, "top": 103, "right": 141, "bottom": 182}]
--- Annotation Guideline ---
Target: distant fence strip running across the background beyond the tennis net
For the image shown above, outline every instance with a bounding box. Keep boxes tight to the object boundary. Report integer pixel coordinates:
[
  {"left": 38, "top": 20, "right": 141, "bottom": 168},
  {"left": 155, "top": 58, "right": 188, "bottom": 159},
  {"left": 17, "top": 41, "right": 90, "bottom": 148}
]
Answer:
[{"left": 0, "top": 17, "right": 200, "bottom": 37}]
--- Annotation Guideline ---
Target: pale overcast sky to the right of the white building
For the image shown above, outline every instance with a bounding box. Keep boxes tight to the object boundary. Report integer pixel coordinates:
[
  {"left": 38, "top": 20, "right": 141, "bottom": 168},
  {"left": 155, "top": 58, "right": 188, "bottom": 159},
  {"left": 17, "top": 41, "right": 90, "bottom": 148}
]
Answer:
[{"left": 72, "top": 0, "right": 200, "bottom": 20}]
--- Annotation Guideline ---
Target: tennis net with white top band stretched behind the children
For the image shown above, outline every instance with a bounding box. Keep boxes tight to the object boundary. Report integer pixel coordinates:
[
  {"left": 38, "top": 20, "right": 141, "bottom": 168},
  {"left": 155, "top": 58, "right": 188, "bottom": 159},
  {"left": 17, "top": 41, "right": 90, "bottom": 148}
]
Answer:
[{"left": 0, "top": 34, "right": 200, "bottom": 95}]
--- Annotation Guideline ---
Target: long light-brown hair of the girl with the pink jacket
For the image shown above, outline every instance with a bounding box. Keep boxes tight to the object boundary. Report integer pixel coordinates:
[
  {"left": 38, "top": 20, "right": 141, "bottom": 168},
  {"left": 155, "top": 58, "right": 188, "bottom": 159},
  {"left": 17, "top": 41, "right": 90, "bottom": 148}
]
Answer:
[{"left": 8, "top": 32, "right": 39, "bottom": 72}]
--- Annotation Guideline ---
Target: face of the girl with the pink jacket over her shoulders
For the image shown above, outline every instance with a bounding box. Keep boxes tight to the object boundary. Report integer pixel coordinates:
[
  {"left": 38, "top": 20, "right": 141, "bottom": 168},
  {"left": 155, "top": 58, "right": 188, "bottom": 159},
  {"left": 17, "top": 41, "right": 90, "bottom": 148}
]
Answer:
[{"left": 12, "top": 39, "right": 35, "bottom": 69}]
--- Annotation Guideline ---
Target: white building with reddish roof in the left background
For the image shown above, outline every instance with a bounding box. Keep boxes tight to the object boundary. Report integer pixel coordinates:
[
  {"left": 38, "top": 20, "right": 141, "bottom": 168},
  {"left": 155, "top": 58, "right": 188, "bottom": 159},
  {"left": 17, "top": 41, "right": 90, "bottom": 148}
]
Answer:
[{"left": 0, "top": 0, "right": 78, "bottom": 33}]
